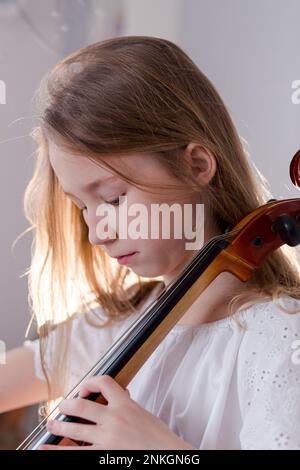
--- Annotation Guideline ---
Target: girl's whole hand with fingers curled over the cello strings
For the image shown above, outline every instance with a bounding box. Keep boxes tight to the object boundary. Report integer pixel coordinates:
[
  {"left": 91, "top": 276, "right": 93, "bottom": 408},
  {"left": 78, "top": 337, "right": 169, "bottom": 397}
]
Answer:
[{"left": 40, "top": 375, "right": 194, "bottom": 450}]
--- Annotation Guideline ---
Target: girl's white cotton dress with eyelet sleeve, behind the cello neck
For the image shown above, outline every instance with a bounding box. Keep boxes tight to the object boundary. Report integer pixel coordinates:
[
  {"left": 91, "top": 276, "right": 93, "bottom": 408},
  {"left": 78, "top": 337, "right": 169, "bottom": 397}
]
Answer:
[{"left": 24, "top": 288, "right": 300, "bottom": 450}]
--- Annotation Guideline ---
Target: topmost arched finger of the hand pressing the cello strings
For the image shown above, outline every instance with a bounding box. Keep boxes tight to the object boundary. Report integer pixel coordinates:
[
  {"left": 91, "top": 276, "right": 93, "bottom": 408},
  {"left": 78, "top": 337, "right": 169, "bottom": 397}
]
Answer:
[{"left": 79, "top": 375, "right": 128, "bottom": 403}]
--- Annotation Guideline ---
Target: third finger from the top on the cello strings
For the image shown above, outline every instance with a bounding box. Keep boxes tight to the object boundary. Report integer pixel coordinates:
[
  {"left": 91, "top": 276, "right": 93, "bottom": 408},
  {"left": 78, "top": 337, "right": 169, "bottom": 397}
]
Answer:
[{"left": 47, "top": 419, "right": 97, "bottom": 444}]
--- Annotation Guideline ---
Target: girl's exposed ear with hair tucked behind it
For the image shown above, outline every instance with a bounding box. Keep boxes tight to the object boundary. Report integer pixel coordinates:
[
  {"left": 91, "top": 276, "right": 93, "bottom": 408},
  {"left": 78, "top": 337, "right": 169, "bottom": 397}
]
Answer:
[{"left": 184, "top": 142, "right": 217, "bottom": 185}]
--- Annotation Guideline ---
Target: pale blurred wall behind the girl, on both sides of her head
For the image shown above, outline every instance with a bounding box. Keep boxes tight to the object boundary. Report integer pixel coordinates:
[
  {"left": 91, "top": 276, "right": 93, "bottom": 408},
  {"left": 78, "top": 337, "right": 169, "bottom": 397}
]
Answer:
[{"left": 0, "top": 0, "right": 300, "bottom": 348}]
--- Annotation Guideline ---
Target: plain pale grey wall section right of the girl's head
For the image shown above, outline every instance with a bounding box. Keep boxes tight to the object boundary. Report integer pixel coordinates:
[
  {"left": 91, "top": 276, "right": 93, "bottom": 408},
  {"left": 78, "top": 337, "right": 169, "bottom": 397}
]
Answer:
[{"left": 180, "top": 0, "right": 300, "bottom": 198}]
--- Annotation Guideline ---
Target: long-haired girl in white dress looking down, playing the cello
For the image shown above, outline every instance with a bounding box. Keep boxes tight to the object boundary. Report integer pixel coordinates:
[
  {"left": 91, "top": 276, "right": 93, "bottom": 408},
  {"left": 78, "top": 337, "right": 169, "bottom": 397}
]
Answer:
[{"left": 1, "top": 36, "right": 300, "bottom": 450}]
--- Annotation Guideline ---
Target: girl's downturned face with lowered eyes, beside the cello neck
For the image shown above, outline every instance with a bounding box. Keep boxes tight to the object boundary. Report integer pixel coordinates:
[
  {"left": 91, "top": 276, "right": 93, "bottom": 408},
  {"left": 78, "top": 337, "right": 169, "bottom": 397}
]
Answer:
[{"left": 49, "top": 140, "right": 209, "bottom": 284}]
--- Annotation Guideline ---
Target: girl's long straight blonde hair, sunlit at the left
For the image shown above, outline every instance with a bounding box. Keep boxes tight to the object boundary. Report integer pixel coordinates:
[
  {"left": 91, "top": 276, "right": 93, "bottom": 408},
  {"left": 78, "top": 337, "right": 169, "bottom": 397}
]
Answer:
[{"left": 20, "top": 36, "right": 300, "bottom": 402}]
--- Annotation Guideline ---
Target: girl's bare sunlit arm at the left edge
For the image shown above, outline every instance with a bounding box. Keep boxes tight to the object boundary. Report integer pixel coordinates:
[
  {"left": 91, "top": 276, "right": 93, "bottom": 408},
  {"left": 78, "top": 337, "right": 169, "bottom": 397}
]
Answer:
[{"left": 0, "top": 346, "right": 47, "bottom": 413}]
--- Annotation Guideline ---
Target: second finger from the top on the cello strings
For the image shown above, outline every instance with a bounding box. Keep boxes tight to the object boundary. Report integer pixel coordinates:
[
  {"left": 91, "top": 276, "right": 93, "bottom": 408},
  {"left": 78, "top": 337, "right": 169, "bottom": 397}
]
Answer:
[{"left": 59, "top": 398, "right": 107, "bottom": 424}]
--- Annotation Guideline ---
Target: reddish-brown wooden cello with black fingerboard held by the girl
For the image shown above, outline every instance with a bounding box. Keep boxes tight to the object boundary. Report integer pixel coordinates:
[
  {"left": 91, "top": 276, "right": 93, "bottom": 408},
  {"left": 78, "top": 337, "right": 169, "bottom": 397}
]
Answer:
[{"left": 17, "top": 150, "right": 300, "bottom": 450}]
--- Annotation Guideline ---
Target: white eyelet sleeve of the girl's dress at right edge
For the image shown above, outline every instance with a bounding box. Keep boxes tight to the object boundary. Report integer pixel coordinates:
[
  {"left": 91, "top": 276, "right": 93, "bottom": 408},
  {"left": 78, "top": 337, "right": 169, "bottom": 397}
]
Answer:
[{"left": 238, "top": 298, "right": 300, "bottom": 450}]
